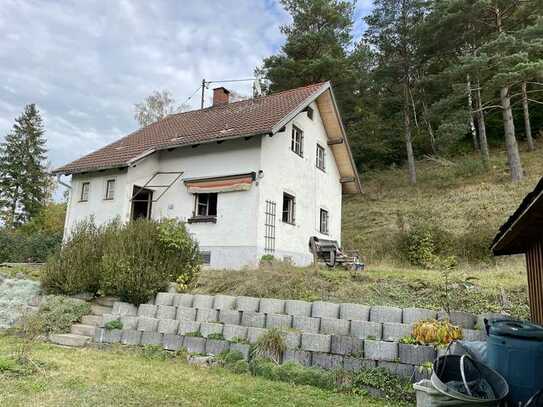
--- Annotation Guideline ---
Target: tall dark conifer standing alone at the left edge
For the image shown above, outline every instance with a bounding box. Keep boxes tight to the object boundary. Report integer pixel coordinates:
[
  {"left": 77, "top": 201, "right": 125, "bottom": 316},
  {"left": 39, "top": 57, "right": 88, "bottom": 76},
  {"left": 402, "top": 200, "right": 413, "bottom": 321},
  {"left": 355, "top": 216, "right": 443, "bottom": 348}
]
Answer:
[{"left": 0, "top": 104, "right": 50, "bottom": 227}]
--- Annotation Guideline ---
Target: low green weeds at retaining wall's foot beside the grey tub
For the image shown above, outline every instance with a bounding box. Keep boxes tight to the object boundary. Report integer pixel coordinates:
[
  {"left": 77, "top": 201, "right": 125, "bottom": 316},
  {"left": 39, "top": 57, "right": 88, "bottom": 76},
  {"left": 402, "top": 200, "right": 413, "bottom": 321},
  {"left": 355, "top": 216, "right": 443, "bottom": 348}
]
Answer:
[{"left": 353, "top": 368, "right": 415, "bottom": 402}]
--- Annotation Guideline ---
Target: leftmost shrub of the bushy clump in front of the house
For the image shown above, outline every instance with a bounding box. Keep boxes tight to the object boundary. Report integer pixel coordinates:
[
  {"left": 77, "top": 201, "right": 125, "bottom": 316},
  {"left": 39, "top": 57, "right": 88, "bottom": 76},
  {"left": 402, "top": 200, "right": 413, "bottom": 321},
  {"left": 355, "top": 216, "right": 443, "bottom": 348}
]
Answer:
[{"left": 41, "top": 220, "right": 103, "bottom": 295}]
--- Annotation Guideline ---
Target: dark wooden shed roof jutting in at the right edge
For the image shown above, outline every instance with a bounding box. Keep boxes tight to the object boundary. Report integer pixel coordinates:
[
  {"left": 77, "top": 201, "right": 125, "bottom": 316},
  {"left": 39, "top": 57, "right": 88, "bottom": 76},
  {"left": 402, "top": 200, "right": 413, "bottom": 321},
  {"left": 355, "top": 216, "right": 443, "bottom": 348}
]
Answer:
[{"left": 492, "top": 178, "right": 543, "bottom": 256}]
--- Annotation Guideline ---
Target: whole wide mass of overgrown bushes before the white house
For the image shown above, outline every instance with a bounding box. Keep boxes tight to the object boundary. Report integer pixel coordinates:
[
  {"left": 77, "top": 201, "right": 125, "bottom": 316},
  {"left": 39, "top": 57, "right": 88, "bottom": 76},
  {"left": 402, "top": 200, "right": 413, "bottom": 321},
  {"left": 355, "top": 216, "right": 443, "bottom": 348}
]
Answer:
[{"left": 42, "top": 219, "right": 201, "bottom": 305}]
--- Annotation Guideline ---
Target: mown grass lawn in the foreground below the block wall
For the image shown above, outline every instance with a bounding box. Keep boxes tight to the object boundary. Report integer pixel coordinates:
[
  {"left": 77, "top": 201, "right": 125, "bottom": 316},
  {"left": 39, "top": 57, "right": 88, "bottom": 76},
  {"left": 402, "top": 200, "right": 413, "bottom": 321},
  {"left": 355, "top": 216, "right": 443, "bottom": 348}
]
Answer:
[{"left": 0, "top": 336, "right": 395, "bottom": 407}]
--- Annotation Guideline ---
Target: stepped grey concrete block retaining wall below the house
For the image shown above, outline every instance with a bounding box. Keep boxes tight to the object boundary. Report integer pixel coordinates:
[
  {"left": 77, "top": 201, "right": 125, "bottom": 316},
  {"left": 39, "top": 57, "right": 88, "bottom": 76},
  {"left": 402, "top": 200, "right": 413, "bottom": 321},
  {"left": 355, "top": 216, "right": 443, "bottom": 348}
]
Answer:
[{"left": 99, "top": 293, "right": 495, "bottom": 379}]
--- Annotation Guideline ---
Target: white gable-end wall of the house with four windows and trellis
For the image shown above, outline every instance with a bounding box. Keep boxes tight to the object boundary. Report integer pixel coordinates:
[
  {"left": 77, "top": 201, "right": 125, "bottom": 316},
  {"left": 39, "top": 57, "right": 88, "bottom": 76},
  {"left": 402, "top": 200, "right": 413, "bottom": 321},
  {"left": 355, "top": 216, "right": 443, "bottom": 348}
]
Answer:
[{"left": 257, "top": 103, "right": 342, "bottom": 265}]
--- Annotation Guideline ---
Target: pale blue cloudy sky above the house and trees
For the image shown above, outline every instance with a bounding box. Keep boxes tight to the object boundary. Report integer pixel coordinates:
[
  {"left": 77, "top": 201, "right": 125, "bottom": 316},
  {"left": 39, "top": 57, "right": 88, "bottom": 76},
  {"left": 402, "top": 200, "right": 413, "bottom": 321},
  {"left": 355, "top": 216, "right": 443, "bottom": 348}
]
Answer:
[{"left": 0, "top": 0, "right": 371, "bottom": 173}]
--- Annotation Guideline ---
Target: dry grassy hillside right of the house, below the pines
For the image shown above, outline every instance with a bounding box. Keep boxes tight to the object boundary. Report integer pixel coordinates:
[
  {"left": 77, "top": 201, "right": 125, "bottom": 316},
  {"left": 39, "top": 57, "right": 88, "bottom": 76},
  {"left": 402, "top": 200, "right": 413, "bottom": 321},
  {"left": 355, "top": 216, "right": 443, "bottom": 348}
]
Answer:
[{"left": 343, "top": 146, "right": 543, "bottom": 265}]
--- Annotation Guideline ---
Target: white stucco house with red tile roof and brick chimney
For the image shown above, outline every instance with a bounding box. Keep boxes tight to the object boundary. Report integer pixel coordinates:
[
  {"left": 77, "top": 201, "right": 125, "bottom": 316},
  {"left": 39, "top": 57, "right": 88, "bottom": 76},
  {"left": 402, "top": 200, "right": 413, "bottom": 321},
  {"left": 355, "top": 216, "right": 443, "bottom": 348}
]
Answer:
[{"left": 54, "top": 82, "right": 361, "bottom": 269}]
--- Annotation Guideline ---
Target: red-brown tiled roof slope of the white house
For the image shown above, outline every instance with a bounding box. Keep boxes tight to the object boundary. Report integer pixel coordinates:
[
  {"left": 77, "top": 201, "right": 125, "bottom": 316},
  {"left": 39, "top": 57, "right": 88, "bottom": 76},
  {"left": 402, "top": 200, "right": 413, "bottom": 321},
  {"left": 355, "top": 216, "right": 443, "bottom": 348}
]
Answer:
[{"left": 53, "top": 83, "right": 325, "bottom": 174}]
